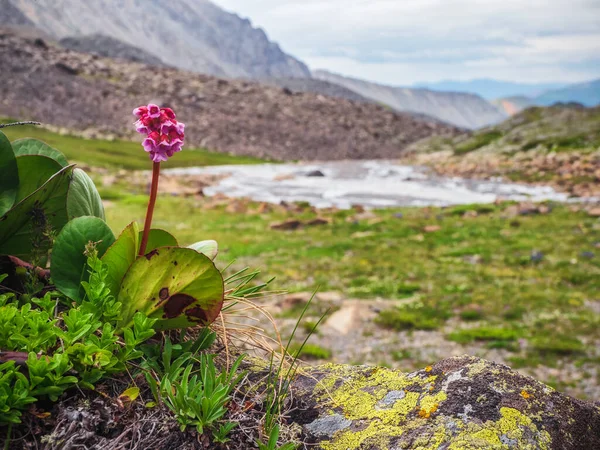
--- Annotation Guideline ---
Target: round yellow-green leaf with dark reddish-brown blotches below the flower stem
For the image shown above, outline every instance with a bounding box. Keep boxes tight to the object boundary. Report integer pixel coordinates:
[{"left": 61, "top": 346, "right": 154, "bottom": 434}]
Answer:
[{"left": 118, "top": 247, "right": 224, "bottom": 330}]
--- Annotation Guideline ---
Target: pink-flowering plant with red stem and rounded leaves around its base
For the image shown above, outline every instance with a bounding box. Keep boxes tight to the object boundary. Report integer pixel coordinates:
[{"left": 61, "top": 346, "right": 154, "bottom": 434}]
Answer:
[{"left": 51, "top": 104, "right": 224, "bottom": 330}]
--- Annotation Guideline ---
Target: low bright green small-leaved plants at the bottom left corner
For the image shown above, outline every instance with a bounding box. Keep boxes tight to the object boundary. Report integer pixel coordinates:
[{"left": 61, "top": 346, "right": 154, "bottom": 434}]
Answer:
[{"left": 0, "top": 253, "right": 155, "bottom": 425}]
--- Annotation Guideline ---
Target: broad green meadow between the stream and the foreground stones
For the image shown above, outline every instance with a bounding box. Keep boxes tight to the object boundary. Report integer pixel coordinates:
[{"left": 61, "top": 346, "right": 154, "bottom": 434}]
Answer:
[{"left": 107, "top": 196, "right": 600, "bottom": 374}]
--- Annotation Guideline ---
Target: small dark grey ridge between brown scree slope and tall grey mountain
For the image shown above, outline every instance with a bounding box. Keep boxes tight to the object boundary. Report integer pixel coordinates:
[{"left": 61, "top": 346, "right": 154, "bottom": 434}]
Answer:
[{"left": 59, "top": 34, "right": 165, "bottom": 66}]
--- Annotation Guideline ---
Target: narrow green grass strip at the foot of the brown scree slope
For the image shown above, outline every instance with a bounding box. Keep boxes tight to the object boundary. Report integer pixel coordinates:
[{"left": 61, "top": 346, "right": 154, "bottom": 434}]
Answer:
[{"left": 0, "top": 120, "right": 262, "bottom": 170}]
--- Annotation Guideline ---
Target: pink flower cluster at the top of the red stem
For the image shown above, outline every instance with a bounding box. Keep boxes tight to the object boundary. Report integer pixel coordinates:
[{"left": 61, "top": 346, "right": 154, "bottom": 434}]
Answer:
[{"left": 133, "top": 104, "right": 185, "bottom": 162}]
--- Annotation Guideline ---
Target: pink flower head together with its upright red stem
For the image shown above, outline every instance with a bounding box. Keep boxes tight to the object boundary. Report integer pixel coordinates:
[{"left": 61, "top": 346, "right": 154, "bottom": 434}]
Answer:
[{"left": 133, "top": 103, "right": 185, "bottom": 256}]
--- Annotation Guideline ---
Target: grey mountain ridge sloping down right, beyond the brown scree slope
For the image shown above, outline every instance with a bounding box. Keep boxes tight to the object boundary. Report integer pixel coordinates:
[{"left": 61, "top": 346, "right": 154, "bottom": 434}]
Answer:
[{"left": 313, "top": 70, "right": 506, "bottom": 129}]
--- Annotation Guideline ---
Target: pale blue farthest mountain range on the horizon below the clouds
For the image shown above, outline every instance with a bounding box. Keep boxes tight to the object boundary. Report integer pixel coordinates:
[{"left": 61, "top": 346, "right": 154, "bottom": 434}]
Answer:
[{"left": 415, "top": 79, "right": 565, "bottom": 100}]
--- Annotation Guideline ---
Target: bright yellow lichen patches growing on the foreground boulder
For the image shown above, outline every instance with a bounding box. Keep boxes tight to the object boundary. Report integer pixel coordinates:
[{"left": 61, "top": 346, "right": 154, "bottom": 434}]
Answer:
[{"left": 314, "top": 366, "right": 551, "bottom": 450}]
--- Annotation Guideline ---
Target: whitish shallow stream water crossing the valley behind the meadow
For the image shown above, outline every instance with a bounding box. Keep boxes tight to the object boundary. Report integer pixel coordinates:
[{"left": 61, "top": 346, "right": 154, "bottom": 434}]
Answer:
[{"left": 167, "top": 160, "right": 568, "bottom": 208}]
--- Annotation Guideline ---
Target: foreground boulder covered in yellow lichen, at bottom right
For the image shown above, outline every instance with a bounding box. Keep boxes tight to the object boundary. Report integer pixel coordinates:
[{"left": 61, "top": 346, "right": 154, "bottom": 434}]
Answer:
[{"left": 291, "top": 356, "right": 600, "bottom": 450}]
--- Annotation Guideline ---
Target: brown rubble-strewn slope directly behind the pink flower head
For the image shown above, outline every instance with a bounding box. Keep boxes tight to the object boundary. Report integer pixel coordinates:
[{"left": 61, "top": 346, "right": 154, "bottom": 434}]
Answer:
[{"left": 0, "top": 32, "right": 459, "bottom": 160}]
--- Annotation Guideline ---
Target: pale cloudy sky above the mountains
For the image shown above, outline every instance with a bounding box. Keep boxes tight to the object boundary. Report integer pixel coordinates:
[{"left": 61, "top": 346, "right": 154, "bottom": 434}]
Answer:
[{"left": 213, "top": 0, "right": 600, "bottom": 86}]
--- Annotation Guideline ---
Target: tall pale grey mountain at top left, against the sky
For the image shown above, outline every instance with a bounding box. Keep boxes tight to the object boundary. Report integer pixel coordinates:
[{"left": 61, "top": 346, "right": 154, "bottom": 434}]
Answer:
[{"left": 7, "top": 0, "right": 310, "bottom": 78}]
